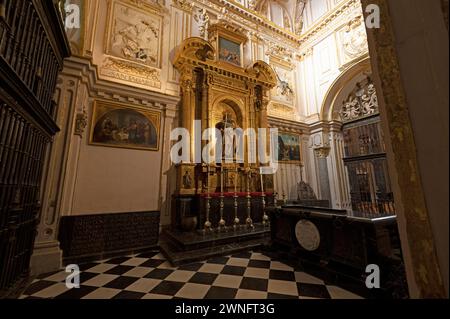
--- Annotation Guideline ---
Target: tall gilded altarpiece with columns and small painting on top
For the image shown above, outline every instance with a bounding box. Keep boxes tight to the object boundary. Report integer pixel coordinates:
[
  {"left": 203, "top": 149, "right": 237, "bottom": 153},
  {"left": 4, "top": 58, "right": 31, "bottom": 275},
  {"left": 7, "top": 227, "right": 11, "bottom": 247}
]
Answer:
[{"left": 173, "top": 24, "right": 277, "bottom": 228}]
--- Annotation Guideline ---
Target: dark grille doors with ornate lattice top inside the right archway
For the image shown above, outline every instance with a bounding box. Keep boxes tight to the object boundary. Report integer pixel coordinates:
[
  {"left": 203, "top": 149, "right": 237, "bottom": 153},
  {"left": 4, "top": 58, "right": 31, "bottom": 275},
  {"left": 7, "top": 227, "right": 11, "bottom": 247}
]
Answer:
[{"left": 339, "top": 76, "right": 395, "bottom": 217}]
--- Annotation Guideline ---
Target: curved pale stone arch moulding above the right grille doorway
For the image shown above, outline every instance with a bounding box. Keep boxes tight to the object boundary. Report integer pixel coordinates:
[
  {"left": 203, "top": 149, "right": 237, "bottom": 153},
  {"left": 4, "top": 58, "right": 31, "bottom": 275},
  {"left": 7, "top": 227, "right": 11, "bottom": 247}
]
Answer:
[{"left": 320, "top": 57, "right": 372, "bottom": 122}]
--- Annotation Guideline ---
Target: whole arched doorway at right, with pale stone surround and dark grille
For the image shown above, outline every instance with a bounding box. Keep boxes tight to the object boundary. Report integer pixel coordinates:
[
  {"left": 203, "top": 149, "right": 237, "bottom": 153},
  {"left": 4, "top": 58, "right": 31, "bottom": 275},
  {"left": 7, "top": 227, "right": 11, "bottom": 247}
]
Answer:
[{"left": 318, "top": 58, "right": 395, "bottom": 217}]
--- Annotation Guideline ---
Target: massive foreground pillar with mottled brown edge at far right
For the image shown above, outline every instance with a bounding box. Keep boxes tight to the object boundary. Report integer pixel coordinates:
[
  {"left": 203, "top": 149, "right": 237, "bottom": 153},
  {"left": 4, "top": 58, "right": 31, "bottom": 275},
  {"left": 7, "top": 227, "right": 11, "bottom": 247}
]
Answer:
[{"left": 362, "top": 0, "right": 449, "bottom": 298}]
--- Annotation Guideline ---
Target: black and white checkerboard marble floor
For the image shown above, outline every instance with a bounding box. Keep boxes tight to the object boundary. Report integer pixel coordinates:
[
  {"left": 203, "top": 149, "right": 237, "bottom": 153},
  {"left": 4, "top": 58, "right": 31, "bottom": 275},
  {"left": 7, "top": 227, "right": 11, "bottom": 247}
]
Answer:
[{"left": 20, "top": 251, "right": 360, "bottom": 299}]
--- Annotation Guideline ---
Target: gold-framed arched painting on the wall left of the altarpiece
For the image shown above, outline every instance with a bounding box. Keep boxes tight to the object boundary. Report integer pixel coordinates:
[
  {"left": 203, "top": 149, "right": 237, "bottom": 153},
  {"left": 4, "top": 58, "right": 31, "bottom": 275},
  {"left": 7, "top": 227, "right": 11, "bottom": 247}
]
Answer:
[{"left": 90, "top": 101, "right": 161, "bottom": 151}]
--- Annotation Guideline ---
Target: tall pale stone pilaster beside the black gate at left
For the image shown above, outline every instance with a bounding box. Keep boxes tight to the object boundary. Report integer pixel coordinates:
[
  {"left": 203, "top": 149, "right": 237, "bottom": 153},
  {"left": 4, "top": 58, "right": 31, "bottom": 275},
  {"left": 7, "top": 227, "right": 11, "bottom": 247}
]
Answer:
[{"left": 31, "top": 75, "right": 88, "bottom": 275}]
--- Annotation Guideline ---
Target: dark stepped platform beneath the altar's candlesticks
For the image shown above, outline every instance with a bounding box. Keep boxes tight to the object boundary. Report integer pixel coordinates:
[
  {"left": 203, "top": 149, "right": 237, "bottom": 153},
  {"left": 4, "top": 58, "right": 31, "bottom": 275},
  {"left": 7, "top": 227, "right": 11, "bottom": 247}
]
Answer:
[{"left": 160, "top": 224, "right": 270, "bottom": 266}]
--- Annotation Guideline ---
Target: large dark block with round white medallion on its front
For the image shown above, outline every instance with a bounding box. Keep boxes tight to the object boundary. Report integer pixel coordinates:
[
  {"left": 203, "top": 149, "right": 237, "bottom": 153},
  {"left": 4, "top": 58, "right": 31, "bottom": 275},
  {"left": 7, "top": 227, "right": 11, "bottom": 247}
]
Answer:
[{"left": 269, "top": 206, "right": 408, "bottom": 299}]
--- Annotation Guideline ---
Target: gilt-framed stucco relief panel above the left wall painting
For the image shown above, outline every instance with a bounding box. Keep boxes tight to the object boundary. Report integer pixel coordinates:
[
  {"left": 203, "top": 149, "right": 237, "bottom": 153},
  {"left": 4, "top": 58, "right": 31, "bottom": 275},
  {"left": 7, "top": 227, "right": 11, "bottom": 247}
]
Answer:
[{"left": 100, "top": 0, "right": 163, "bottom": 89}]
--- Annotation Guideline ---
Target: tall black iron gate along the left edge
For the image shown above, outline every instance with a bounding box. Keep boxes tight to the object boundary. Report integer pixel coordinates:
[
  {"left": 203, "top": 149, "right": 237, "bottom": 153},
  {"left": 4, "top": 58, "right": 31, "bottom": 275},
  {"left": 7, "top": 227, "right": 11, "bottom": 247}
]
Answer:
[{"left": 0, "top": 0, "right": 70, "bottom": 298}]
